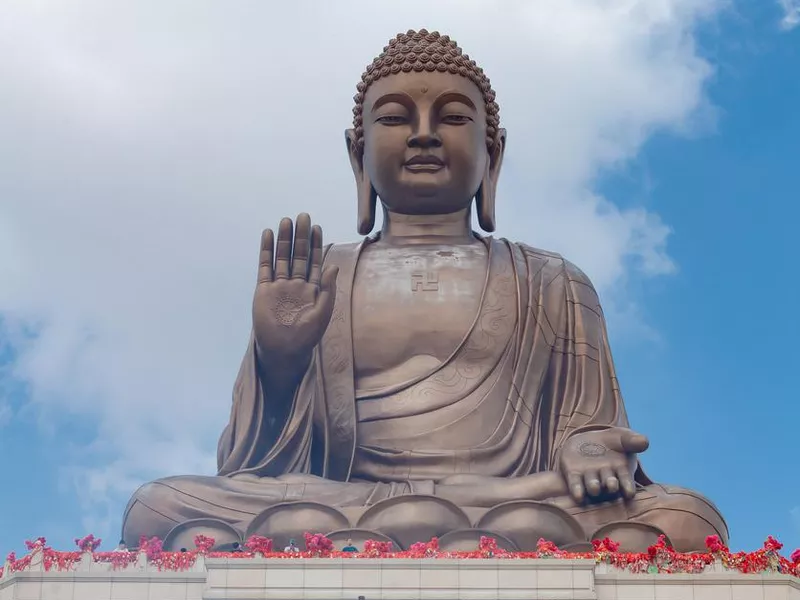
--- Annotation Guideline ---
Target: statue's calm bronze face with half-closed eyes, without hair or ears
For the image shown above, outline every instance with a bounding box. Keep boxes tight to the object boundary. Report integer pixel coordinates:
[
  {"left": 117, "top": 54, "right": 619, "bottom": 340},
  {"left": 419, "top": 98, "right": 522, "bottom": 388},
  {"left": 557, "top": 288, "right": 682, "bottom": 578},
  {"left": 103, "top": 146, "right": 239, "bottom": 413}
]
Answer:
[{"left": 363, "top": 72, "right": 489, "bottom": 214}]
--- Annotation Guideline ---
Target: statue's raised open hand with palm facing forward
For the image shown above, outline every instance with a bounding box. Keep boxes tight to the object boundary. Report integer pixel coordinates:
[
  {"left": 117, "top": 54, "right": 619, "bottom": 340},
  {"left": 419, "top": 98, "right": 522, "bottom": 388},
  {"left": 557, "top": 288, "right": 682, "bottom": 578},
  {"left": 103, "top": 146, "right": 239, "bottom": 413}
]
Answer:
[{"left": 253, "top": 213, "right": 339, "bottom": 369}]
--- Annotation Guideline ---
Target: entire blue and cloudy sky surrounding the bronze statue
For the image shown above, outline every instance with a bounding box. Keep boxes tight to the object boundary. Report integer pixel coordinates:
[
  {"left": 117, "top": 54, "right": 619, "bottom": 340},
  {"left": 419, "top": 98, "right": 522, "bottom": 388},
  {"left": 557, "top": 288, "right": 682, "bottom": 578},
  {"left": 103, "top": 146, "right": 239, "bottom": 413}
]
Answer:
[{"left": 0, "top": 0, "right": 800, "bottom": 552}]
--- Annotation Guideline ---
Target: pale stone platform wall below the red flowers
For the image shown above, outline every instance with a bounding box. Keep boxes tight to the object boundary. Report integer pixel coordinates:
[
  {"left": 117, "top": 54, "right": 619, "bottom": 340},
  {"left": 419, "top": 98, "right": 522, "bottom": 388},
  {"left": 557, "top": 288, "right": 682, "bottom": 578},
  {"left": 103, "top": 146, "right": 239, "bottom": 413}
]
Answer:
[{"left": 0, "top": 555, "right": 800, "bottom": 600}]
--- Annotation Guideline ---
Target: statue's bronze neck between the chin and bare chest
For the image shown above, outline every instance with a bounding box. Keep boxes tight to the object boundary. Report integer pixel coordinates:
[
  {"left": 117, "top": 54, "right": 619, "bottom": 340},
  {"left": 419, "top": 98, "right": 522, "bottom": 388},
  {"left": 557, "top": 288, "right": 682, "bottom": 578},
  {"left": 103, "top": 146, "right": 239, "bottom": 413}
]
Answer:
[{"left": 381, "top": 207, "right": 476, "bottom": 245}]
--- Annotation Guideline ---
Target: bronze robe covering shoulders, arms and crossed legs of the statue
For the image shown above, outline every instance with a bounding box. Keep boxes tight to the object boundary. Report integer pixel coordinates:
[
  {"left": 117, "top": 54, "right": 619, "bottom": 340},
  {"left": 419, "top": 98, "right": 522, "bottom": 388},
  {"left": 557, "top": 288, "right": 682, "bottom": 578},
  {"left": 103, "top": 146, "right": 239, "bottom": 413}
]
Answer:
[{"left": 123, "top": 238, "right": 727, "bottom": 551}]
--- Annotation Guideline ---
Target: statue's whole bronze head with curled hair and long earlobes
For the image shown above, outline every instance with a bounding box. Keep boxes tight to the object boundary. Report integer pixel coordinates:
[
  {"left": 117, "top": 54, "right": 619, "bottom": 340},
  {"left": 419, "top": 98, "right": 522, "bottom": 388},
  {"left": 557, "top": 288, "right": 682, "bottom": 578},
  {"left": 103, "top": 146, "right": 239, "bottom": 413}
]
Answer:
[{"left": 346, "top": 29, "right": 506, "bottom": 235}]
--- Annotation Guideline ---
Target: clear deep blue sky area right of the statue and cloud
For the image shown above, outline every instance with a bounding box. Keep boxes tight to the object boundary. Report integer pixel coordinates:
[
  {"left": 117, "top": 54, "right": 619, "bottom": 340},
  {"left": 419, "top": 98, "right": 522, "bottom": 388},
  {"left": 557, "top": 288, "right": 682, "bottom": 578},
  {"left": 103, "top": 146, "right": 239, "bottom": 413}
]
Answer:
[{"left": 602, "top": 2, "right": 800, "bottom": 548}]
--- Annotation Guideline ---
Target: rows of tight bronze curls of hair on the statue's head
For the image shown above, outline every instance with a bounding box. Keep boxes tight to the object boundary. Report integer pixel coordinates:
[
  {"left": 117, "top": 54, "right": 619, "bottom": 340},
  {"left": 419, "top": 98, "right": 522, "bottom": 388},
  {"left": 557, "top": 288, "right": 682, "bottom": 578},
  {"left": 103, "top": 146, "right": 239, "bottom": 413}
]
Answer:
[{"left": 353, "top": 29, "right": 500, "bottom": 152}]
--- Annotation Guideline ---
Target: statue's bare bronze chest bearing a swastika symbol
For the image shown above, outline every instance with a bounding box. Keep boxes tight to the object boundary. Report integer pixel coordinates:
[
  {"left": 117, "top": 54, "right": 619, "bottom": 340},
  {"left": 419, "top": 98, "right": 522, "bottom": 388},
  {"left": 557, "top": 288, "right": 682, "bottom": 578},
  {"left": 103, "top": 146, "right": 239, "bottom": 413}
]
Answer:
[{"left": 352, "top": 244, "right": 487, "bottom": 387}]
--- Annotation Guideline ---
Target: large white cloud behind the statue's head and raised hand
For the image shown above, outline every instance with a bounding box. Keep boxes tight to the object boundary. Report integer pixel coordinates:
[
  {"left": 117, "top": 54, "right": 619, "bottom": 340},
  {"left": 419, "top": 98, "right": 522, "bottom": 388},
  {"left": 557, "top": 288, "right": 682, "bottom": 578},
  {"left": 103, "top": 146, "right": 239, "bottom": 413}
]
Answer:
[{"left": 0, "top": 0, "right": 717, "bottom": 536}]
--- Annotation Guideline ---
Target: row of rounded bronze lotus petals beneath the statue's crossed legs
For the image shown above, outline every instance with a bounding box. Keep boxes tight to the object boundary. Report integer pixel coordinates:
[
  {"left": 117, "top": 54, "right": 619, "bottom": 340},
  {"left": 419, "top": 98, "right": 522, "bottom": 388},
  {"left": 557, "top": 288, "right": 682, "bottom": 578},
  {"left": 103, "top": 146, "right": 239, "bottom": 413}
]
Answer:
[{"left": 152, "top": 495, "right": 680, "bottom": 552}]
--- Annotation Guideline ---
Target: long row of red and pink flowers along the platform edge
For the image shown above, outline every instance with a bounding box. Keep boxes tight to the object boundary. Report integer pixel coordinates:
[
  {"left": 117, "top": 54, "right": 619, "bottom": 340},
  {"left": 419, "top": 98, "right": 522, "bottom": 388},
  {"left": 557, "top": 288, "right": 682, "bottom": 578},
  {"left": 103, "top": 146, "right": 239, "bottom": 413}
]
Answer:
[{"left": 0, "top": 533, "right": 800, "bottom": 577}]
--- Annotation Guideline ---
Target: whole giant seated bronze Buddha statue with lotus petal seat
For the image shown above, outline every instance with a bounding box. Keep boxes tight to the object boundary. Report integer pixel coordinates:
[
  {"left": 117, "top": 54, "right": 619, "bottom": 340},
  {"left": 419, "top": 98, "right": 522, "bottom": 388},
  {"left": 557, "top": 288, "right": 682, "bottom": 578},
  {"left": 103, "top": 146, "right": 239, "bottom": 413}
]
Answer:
[{"left": 123, "top": 30, "right": 728, "bottom": 551}]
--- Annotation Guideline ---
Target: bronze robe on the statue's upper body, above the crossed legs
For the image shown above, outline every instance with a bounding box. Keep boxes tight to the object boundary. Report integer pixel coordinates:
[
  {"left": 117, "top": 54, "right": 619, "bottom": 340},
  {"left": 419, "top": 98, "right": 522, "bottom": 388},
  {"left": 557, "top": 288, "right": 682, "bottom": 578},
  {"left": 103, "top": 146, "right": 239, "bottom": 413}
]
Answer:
[{"left": 218, "top": 238, "right": 649, "bottom": 488}]
